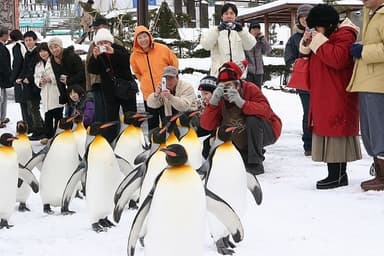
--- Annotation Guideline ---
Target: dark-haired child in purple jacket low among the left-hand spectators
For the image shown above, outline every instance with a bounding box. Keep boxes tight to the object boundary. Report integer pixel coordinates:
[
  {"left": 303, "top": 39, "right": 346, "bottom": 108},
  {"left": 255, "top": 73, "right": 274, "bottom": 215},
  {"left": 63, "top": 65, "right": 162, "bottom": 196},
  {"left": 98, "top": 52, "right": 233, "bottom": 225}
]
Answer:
[{"left": 67, "top": 85, "right": 95, "bottom": 127}]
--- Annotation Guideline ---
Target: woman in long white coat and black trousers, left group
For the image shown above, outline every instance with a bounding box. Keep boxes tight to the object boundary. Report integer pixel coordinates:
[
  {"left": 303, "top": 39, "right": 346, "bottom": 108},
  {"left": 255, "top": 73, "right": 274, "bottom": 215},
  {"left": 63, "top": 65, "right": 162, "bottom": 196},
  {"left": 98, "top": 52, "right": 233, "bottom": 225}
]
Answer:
[{"left": 34, "top": 43, "right": 63, "bottom": 144}]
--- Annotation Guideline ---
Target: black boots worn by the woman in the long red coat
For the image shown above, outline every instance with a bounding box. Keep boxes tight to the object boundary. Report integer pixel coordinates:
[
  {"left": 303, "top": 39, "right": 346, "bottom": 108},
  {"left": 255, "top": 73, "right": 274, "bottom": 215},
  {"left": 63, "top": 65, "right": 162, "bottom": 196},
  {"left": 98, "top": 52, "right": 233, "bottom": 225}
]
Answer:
[{"left": 316, "top": 163, "right": 348, "bottom": 189}]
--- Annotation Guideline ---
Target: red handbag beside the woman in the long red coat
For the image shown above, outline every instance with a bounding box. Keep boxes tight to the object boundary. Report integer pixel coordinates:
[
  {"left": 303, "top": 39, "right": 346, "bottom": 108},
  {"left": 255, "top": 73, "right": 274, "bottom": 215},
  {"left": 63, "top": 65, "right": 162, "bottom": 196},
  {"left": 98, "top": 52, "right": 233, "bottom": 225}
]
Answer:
[{"left": 287, "top": 57, "right": 309, "bottom": 91}]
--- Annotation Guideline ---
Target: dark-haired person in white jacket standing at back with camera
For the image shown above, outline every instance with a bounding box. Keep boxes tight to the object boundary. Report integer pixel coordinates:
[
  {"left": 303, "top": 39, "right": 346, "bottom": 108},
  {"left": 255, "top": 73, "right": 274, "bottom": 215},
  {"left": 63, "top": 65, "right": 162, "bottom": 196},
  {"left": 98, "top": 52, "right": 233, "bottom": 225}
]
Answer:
[{"left": 200, "top": 3, "right": 256, "bottom": 77}]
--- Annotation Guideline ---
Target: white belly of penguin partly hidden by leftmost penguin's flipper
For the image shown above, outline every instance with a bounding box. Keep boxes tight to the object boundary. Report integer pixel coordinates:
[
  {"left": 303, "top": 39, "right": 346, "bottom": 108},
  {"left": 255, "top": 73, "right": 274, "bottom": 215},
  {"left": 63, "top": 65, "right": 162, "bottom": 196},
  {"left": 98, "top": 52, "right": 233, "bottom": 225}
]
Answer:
[{"left": 12, "top": 136, "right": 32, "bottom": 203}]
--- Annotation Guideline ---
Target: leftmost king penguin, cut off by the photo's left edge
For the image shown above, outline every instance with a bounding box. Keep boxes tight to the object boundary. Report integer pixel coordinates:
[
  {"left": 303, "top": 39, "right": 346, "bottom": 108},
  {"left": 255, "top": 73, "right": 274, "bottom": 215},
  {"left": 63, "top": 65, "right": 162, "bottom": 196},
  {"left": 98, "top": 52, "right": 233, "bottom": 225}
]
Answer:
[{"left": 0, "top": 133, "right": 38, "bottom": 229}]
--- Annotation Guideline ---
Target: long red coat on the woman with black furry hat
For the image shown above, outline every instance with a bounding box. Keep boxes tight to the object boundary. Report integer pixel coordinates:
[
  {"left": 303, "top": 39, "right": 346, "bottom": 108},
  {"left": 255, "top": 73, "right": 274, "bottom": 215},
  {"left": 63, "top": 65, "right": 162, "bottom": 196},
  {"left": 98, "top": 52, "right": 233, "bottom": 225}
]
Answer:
[{"left": 309, "top": 27, "right": 359, "bottom": 136}]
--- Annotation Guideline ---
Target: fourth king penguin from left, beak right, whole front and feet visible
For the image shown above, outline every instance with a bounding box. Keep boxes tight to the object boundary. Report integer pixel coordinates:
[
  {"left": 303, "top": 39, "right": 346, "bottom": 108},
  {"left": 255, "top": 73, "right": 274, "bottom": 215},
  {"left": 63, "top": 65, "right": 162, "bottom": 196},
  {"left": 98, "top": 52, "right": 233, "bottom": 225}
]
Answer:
[{"left": 62, "top": 122, "right": 124, "bottom": 232}]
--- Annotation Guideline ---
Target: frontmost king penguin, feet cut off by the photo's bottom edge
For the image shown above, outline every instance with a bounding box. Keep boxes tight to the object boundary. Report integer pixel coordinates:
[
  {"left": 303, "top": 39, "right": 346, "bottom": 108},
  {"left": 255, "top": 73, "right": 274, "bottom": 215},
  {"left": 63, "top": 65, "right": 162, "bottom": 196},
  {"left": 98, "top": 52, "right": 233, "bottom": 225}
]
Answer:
[{"left": 128, "top": 144, "right": 243, "bottom": 256}]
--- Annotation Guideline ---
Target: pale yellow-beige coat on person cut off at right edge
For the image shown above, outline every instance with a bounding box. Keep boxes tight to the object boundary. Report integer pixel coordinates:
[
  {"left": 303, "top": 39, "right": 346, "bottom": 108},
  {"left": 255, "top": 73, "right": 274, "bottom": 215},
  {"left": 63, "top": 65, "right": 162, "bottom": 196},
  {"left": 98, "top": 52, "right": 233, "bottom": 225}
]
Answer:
[{"left": 347, "top": 8, "right": 384, "bottom": 93}]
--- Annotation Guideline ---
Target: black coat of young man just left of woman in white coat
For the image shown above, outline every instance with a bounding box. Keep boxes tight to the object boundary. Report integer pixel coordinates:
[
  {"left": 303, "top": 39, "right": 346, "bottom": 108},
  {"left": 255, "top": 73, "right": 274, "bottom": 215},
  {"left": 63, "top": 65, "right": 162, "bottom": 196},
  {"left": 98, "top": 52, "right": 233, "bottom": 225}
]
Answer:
[{"left": 15, "top": 46, "right": 41, "bottom": 102}]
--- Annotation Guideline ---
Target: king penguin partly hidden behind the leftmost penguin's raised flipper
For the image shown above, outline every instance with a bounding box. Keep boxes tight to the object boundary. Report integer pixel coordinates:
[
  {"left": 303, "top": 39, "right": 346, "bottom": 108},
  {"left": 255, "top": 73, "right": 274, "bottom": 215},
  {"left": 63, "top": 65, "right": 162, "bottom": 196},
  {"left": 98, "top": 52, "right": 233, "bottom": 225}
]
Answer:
[{"left": 12, "top": 121, "right": 32, "bottom": 212}]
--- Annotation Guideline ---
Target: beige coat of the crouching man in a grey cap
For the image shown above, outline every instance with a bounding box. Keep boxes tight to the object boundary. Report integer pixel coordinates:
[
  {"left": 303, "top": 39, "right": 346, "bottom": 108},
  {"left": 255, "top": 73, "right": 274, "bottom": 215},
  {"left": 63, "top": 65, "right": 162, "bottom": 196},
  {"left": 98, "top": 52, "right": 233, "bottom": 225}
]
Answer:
[{"left": 147, "top": 79, "right": 196, "bottom": 116}]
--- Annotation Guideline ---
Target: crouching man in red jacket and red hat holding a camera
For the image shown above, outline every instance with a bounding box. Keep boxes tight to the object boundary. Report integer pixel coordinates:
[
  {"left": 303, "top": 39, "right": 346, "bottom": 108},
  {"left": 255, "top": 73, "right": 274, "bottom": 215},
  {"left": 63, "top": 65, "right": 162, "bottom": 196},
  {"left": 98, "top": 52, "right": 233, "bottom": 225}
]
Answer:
[{"left": 200, "top": 61, "right": 282, "bottom": 174}]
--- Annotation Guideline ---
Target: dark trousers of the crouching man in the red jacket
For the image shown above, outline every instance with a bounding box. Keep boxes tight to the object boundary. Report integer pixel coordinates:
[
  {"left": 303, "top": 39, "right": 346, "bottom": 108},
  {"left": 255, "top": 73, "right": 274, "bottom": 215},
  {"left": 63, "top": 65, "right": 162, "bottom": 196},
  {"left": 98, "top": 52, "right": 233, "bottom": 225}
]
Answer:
[{"left": 239, "top": 116, "right": 276, "bottom": 164}]
